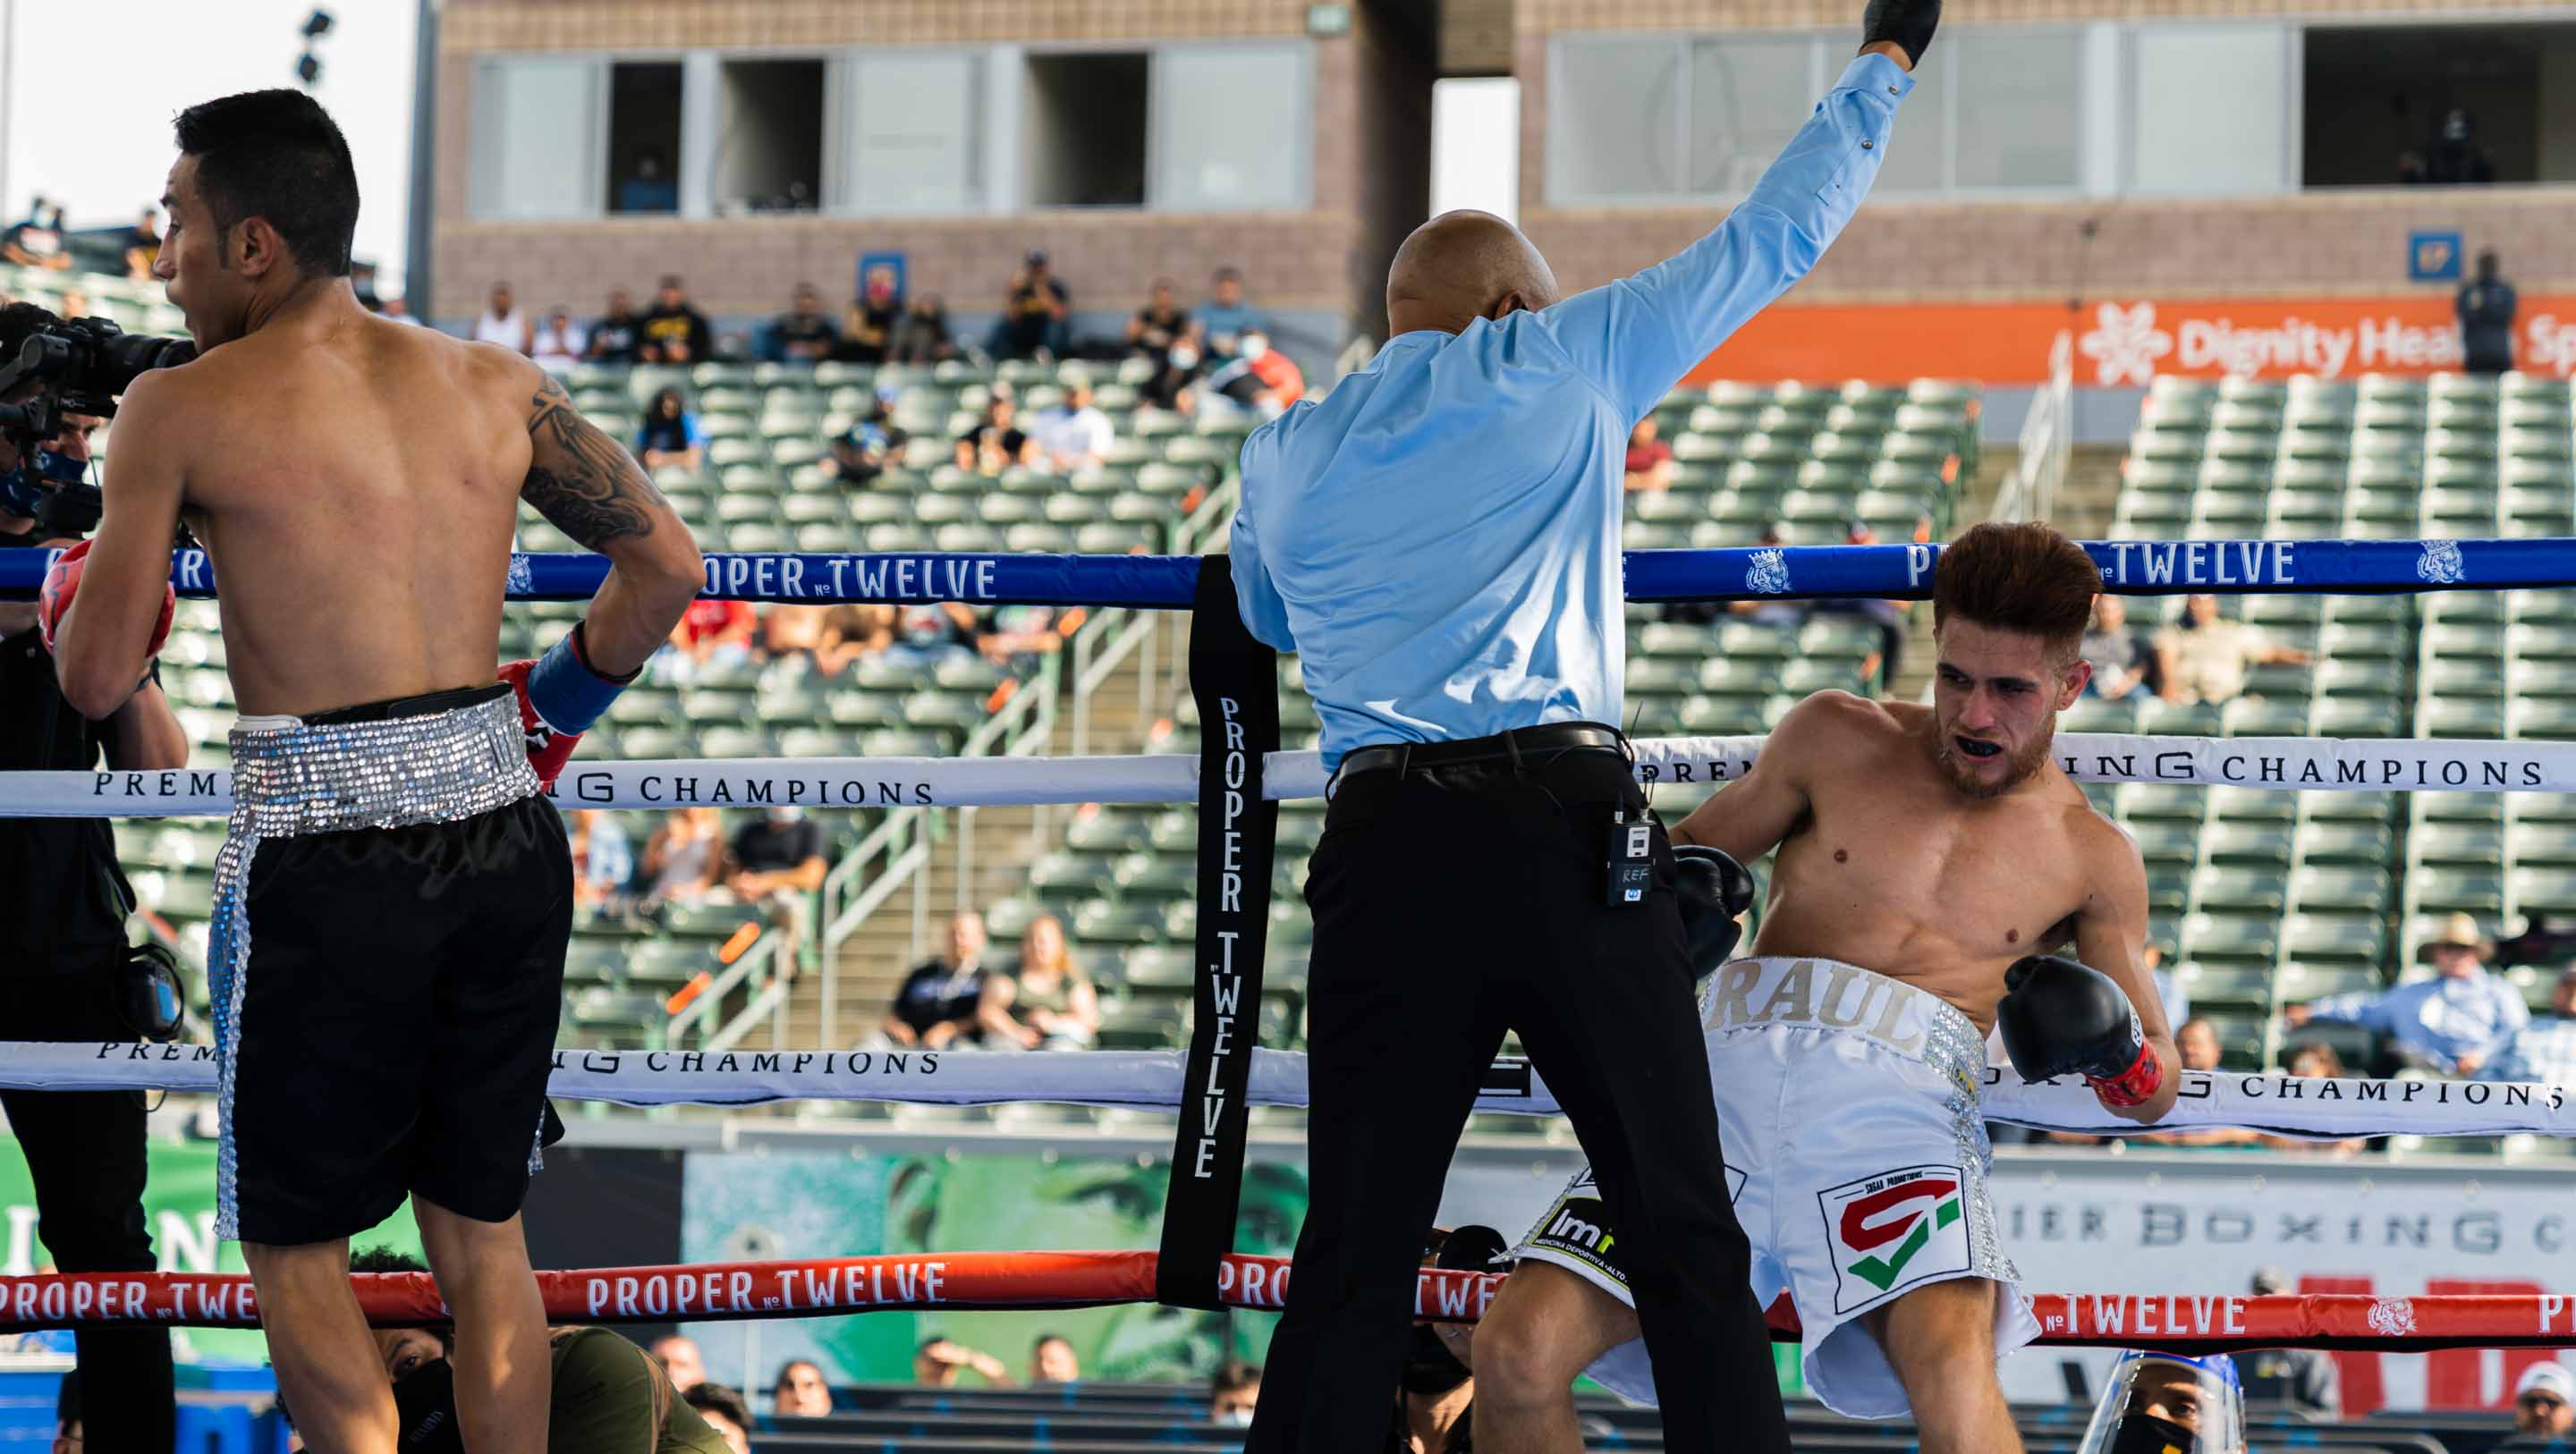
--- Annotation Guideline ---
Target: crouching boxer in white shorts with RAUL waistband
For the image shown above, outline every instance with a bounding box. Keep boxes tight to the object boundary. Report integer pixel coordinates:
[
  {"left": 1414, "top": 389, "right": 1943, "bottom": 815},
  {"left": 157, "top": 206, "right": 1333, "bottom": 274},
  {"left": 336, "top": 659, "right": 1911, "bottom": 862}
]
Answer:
[{"left": 1476, "top": 522, "right": 2179, "bottom": 1454}]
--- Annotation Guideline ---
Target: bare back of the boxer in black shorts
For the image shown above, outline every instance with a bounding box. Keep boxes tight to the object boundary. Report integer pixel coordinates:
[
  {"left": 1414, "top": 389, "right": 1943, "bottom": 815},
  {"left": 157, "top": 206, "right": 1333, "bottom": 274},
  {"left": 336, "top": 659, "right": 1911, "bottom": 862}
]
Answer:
[{"left": 150, "top": 314, "right": 541, "bottom": 713}]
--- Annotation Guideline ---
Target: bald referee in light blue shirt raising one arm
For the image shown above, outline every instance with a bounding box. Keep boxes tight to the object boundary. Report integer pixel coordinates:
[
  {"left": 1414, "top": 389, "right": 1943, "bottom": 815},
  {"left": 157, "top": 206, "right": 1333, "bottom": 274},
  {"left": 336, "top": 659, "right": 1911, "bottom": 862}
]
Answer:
[{"left": 1232, "top": 0, "right": 1940, "bottom": 1454}]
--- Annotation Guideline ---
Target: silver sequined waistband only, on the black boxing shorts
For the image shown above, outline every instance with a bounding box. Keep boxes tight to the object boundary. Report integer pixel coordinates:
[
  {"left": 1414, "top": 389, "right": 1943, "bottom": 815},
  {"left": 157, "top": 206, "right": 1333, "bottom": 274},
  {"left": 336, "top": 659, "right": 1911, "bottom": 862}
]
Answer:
[{"left": 232, "top": 695, "right": 538, "bottom": 836}]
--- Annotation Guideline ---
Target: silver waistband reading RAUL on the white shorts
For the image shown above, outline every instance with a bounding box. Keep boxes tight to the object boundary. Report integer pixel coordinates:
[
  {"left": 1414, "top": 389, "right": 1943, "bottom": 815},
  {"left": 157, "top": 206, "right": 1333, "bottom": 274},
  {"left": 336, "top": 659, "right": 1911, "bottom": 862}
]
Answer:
[{"left": 1700, "top": 955, "right": 1986, "bottom": 1081}]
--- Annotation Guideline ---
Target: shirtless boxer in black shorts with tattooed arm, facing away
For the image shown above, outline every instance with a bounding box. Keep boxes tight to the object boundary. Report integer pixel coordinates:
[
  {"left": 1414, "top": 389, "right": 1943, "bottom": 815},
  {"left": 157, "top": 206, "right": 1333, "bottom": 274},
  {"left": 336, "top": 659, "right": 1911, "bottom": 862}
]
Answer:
[{"left": 57, "top": 90, "right": 703, "bottom": 1454}]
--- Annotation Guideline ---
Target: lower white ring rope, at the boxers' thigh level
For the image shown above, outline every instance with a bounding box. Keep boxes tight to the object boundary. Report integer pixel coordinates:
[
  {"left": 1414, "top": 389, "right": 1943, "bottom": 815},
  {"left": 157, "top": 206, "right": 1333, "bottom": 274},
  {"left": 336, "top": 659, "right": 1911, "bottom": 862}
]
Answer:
[{"left": 0, "top": 1043, "right": 2576, "bottom": 1140}]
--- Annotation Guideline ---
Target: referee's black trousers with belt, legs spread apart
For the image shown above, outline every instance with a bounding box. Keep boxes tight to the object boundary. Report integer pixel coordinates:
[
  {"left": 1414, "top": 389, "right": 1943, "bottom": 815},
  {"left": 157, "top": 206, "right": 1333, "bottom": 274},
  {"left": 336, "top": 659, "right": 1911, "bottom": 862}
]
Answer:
[{"left": 1247, "top": 751, "right": 1788, "bottom": 1454}]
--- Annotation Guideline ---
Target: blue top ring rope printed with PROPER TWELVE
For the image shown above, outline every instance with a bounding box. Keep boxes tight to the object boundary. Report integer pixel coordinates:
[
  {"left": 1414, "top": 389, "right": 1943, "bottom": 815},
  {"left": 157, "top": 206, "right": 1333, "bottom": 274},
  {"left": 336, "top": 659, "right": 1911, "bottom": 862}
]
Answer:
[{"left": 0, "top": 536, "right": 2545, "bottom": 610}]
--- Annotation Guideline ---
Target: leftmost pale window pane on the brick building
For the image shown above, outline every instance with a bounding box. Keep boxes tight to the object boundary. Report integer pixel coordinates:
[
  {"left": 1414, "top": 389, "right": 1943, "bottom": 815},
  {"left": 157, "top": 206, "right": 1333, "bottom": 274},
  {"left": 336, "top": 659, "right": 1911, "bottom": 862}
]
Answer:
[{"left": 466, "top": 56, "right": 600, "bottom": 219}]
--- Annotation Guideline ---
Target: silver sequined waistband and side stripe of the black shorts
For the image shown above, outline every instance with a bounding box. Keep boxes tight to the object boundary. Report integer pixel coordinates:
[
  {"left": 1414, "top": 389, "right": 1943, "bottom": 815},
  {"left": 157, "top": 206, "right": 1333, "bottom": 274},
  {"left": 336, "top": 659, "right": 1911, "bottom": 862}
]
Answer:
[{"left": 206, "top": 695, "right": 544, "bottom": 1240}]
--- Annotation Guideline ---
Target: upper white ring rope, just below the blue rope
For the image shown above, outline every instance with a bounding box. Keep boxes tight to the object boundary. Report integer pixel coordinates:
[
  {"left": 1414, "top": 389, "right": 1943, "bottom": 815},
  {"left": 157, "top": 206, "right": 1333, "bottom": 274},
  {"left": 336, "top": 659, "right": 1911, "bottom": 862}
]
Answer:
[{"left": 0, "top": 733, "right": 2576, "bottom": 818}]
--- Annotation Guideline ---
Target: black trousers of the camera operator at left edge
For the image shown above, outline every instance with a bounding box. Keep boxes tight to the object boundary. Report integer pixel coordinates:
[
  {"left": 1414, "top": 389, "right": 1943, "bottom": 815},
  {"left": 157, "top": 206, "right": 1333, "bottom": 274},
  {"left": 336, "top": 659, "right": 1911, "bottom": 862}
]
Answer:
[{"left": 0, "top": 952, "right": 178, "bottom": 1454}]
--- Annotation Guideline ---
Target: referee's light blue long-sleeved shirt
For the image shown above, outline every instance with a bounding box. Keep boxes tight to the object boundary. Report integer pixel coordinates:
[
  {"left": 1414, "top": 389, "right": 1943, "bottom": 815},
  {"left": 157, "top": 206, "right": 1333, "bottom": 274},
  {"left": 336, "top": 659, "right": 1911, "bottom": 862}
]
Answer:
[{"left": 1232, "top": 54, "right": 1914, "bottom": 769}]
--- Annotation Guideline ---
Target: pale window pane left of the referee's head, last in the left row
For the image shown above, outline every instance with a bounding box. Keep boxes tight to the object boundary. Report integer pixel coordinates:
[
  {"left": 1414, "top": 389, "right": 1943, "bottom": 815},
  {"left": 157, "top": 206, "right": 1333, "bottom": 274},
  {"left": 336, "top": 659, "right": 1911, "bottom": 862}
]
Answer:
[{"left": 1154, "top": 46, "right": 1314, "bottom": 211}]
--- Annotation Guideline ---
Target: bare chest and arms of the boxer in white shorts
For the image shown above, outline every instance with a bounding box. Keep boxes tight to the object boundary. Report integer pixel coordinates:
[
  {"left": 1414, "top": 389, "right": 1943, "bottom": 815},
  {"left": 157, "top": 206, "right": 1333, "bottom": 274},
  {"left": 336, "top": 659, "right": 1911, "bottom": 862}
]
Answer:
[{"left": 1685, "top": 692, "right": 2161, "bottom": 1029}]
